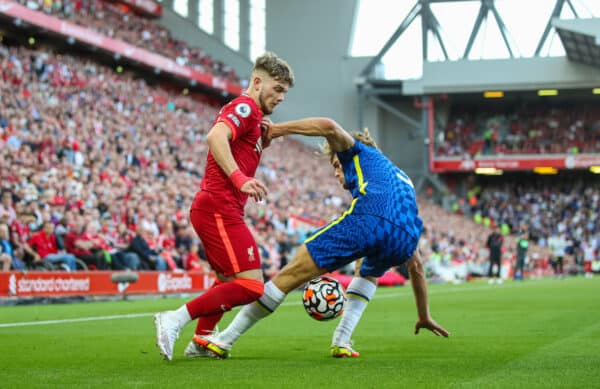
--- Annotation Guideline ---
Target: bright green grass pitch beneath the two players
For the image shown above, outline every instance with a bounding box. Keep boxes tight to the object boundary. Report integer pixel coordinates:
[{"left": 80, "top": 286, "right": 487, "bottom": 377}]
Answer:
[{"left": 0, "top": 277, "right": 600, "bottom": 388}]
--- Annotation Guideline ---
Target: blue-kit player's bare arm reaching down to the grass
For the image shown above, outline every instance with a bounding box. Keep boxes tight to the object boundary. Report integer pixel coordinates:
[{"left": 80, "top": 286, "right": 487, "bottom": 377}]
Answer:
[{"left": 407, "top": 250, "right": 450, "bottom": 338}]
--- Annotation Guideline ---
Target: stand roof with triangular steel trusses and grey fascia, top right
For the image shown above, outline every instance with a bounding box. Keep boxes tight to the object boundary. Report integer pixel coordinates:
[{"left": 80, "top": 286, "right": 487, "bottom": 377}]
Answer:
[{"left": 356, "top": 0, "right": 600, "bottom": 95}]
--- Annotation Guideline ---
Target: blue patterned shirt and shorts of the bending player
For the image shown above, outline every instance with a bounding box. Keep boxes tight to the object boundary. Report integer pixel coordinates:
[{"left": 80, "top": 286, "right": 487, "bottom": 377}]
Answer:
[{"left": 305, "top": 141, "right": 423, "bottom": 277}]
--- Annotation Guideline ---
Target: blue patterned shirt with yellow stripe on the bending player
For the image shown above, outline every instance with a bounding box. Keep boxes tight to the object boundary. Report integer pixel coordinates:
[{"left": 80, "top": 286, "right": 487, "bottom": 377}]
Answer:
[{"left": 337, "top": 141, "right": 423, "bottom": 239}]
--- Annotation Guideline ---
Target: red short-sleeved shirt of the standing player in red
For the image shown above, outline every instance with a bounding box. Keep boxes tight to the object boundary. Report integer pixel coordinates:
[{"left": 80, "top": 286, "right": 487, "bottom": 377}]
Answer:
[{"left": 200, "top": 95, "right": 263, "bottom": 213}]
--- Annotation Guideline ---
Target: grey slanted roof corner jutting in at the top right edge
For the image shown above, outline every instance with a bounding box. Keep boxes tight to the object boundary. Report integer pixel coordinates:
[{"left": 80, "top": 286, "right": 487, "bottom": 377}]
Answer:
[{"left": 552, "top": 18, "right": 600, "bottom": 67}]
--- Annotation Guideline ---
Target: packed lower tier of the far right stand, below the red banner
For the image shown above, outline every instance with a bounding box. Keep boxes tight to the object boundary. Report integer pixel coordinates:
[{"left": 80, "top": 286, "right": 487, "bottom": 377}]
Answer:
[{"left": 428, "top": 167, "right": 600, "bottom": 274}]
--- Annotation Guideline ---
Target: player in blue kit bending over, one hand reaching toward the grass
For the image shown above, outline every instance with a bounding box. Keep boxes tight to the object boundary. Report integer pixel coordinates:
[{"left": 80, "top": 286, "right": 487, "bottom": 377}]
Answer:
[{"left": 194, "top": 118, "right": 449, "bottom": 358}]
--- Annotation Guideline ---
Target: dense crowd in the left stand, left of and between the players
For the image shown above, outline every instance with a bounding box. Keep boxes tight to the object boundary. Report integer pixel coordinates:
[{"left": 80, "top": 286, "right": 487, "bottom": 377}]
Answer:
[{"left": 0, "top": 41, "right": 347, "bottom": 270}]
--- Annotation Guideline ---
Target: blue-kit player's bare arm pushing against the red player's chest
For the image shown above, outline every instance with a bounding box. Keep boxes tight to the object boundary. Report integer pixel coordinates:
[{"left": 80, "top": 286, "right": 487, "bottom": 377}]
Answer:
[{"left": 269, "top": 118, "right": 354, "bottom": 152}]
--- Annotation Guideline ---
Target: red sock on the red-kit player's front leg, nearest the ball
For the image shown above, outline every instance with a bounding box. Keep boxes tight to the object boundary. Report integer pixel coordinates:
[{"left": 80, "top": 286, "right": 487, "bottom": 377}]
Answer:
[{"left": 186, "top": 278, "right": 264, "bottom": 320}]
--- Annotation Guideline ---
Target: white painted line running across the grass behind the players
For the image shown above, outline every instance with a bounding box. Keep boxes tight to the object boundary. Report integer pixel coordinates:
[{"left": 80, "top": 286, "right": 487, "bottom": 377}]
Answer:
[{"left": 0, "top": 284, "right": 523, "bottom": 328}]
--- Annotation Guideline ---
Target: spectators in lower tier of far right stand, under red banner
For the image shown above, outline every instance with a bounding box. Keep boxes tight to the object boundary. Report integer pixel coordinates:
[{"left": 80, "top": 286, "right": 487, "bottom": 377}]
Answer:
[{"left": 463, "top": 174, "right": 600, "bottom": 273}]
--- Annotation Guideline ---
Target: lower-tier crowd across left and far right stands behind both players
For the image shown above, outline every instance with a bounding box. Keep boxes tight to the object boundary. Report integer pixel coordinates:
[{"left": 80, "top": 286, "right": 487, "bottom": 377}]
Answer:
[{"left": 0, "top": 39, "right": 600, "bottom": 279}]
